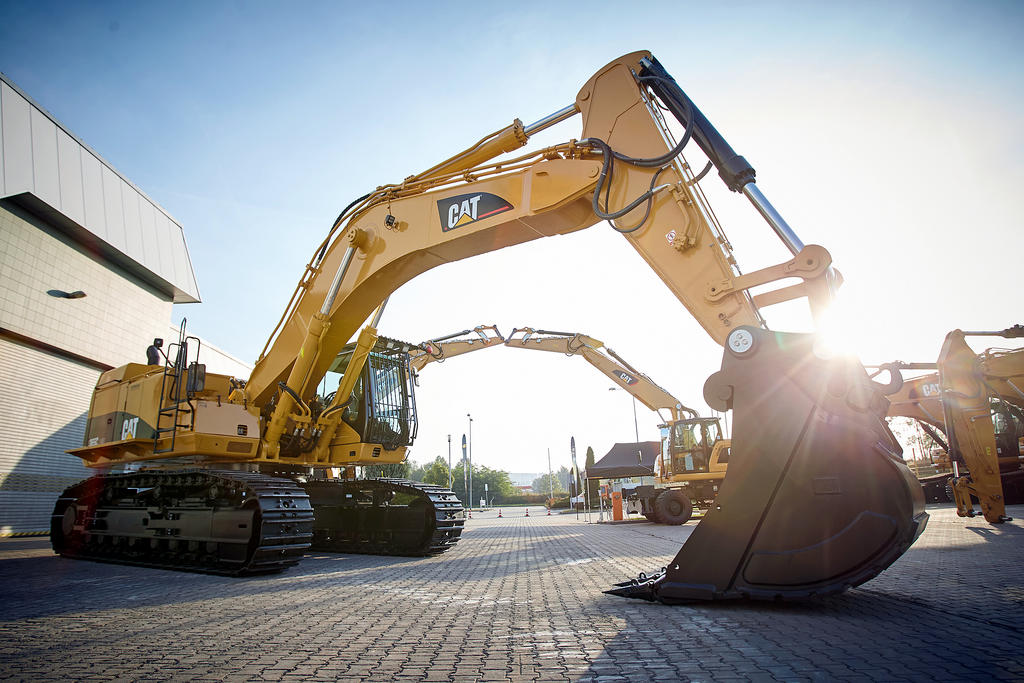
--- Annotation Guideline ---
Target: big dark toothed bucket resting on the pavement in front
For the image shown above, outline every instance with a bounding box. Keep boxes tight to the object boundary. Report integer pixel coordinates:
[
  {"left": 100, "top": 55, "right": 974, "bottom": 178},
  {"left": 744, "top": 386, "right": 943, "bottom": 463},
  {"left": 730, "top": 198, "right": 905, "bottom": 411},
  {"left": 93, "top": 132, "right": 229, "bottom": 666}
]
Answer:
[{"left": 607, "top": 327, "right": 928, "bottom": 603}]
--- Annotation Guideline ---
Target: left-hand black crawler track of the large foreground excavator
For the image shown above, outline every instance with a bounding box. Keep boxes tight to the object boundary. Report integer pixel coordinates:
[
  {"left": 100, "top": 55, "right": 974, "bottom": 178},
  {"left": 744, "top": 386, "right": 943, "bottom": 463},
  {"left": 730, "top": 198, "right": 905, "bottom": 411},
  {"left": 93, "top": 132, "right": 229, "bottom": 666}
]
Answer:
[{"left": 50, "top": 470, "right": 313, "bottom": 575}]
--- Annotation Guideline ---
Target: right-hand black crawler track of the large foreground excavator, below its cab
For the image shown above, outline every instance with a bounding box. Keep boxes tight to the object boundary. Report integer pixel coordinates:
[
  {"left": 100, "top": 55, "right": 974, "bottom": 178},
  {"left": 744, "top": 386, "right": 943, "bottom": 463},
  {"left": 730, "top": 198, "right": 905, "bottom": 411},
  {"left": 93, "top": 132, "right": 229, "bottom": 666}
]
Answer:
[{"left": 303, "top": 479, "right": 466, "bottom": 556}]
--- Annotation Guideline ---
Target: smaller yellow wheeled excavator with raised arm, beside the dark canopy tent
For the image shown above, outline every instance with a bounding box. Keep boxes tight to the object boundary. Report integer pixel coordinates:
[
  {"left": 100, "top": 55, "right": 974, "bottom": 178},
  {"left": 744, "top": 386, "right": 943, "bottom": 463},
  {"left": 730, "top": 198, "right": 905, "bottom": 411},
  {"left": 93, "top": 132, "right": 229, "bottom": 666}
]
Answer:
[{"left": 505, "top": 328, "right": 732, "bottom": 525}]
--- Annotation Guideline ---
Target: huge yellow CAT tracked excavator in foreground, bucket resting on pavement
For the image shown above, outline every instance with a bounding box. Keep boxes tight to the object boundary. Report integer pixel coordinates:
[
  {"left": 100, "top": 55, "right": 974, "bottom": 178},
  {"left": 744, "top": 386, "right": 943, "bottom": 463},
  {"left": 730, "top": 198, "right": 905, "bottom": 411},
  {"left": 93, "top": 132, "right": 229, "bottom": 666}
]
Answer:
[{"left": 51, "top": 51, "right": 928, "bottom": 603}]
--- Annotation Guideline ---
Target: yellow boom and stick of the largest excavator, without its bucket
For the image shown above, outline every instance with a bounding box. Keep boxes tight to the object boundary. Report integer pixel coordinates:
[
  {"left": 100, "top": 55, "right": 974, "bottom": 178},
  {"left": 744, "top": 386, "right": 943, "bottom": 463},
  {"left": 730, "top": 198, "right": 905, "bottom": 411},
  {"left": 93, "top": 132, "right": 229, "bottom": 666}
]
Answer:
[{"left": 246, "top": 52, "right": 834, "bottom": 428}]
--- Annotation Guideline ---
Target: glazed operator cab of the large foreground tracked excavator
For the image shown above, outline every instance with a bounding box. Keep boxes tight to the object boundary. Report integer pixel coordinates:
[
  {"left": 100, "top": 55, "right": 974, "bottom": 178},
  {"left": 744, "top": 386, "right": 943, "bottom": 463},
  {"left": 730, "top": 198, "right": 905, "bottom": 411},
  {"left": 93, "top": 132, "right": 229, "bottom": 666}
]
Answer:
[{"left": 331, "top": 337, "right": 417, "bottom": 451}]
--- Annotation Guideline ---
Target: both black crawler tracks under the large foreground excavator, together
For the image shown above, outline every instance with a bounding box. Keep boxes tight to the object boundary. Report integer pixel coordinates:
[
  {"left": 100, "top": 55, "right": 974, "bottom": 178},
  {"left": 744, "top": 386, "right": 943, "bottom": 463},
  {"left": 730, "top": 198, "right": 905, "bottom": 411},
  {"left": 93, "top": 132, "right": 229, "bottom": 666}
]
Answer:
[{"left": 50, "top": 469, "right": 465, "bottom": 575}]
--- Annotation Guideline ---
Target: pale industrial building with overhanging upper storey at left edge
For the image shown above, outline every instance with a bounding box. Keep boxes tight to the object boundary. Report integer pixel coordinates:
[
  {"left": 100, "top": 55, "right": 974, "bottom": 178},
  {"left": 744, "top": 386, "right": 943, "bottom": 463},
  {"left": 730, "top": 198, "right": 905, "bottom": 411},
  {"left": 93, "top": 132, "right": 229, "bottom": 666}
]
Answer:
[{"left": 0, "top": 75, "right": 250, "bottom": 536}]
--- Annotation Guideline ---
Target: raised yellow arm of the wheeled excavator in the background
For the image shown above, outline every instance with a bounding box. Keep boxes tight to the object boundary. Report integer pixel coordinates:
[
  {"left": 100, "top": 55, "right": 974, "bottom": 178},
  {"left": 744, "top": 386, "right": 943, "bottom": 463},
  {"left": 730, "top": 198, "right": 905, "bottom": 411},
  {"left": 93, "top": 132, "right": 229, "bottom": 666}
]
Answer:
[{"left": 505, "top": 328, "right": 697, "bottom": 422}]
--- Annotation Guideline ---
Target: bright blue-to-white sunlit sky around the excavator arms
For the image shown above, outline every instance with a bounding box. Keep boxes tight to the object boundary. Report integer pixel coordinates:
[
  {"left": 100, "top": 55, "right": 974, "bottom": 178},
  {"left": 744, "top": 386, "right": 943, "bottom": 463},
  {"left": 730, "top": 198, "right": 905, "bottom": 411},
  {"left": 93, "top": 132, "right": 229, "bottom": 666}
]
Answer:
[{"left": 0, "top": 0, "right": 1024, "bottom": 472}]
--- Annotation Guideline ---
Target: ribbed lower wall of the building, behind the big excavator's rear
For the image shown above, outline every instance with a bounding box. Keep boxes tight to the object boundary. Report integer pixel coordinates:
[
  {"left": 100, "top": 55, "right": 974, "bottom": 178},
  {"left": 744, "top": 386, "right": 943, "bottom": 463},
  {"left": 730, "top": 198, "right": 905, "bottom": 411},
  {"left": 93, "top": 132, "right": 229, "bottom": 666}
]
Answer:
[{"left": 0, "top": 337, "right": 99, "bottom": 536}]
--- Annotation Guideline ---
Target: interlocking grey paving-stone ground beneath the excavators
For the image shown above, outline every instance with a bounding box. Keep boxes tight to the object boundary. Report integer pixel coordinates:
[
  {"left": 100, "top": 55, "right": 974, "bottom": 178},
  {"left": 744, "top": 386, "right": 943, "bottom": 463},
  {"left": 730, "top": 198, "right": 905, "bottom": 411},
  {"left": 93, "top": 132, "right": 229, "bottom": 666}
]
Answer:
[{"left": 0, "top": 506, "right": 1024, "bottom": 681}]
